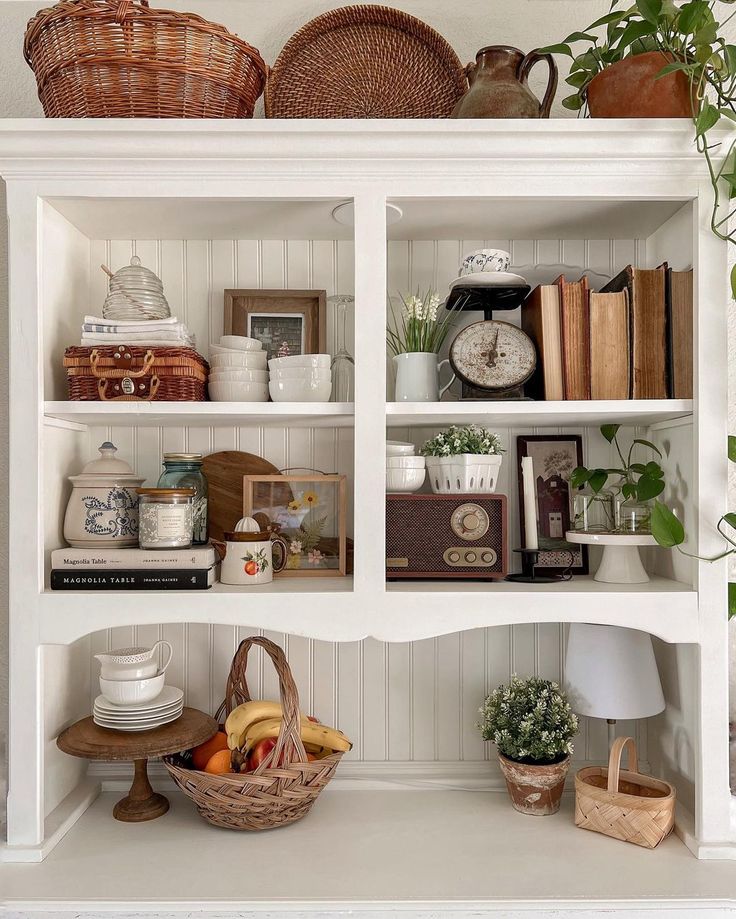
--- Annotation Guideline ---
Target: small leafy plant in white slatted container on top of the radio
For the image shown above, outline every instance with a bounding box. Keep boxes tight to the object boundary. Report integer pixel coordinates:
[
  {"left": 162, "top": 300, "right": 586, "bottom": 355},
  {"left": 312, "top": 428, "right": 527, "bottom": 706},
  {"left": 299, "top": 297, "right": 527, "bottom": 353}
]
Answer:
[{"left": 420, "top": 424, "right": 503, "bottom": 495}]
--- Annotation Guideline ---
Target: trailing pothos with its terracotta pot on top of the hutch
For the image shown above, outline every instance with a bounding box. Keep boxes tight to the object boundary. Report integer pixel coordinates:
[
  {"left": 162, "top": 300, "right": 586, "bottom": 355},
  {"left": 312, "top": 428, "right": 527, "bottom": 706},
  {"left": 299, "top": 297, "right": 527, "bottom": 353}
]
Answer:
[{"left": 539, "top": 0, "right": 736, "bottom": 298}]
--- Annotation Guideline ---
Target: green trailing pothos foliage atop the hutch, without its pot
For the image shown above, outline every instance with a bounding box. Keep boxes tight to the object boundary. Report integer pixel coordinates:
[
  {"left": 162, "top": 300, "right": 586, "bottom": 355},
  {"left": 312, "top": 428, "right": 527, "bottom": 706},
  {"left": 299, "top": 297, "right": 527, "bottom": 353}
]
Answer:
[{"left": 540, "top": 0, "right": 736, "bottom": 299}]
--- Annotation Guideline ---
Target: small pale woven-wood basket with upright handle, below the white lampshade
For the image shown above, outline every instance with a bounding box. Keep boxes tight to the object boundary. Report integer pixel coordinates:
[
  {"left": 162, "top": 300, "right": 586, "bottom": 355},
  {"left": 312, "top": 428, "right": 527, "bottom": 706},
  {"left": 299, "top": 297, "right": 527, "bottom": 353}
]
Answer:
[{"left": 575, "top": 737, "right": 675, "bottom": 849}]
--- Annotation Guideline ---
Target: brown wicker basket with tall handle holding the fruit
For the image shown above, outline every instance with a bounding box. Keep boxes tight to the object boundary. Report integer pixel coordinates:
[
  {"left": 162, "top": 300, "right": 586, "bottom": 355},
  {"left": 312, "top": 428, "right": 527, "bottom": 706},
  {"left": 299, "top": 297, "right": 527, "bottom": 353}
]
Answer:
[{"left": 164, "top": 637, "right": 342, "bottom": 830}]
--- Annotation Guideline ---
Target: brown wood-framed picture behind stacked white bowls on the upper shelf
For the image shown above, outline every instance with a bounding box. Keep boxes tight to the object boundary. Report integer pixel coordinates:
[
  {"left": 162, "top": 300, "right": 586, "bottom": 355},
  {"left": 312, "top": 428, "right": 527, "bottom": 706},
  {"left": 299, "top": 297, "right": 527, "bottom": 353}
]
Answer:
[{"left": 225, "top": 290, "right": 327, "bottom": 360}]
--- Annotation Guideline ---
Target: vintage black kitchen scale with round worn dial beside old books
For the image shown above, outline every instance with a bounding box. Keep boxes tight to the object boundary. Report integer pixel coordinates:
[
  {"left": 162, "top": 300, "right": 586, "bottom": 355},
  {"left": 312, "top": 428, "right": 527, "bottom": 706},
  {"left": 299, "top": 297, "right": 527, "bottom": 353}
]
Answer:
[{"left": 446, "top": 284, "right": 537, "bottom": 400}]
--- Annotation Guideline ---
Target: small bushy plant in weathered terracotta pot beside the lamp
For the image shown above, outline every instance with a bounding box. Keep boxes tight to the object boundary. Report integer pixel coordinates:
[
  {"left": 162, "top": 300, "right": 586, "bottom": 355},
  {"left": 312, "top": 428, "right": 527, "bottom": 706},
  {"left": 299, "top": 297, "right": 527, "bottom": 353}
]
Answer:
[{"left": 478, "top": 675, "right": 578, "bottom": 817}]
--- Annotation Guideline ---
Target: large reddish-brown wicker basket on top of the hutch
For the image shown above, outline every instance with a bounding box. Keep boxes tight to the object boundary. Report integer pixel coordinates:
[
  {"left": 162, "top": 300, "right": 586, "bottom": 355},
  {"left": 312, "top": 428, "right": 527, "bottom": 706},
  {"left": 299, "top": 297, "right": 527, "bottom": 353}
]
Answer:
[{"left": 23, "top": 0, "right": 267, "bottom": 118}]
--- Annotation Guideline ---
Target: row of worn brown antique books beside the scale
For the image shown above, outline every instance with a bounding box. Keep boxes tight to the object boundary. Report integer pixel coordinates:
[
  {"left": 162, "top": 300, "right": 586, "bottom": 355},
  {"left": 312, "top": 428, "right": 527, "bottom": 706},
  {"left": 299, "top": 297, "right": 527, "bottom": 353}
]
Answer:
[{"left": 521, "top": 263, "right": 693, "bottom": 400}]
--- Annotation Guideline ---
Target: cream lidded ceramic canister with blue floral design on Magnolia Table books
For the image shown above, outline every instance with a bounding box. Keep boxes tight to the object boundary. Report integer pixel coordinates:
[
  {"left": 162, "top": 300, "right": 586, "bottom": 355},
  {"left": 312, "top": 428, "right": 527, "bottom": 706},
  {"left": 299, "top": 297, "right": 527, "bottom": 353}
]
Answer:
[{"left": 64, "top": 441, "right": 144, "bottom": 548}]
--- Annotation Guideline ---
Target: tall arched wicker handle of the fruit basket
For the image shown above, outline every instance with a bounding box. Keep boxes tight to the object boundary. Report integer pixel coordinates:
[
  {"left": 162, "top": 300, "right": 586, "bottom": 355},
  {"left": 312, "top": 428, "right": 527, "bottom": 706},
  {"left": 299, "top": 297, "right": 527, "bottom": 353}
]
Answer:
[{"left": 215, "top": 635, "right": 307, "bottom": 775}]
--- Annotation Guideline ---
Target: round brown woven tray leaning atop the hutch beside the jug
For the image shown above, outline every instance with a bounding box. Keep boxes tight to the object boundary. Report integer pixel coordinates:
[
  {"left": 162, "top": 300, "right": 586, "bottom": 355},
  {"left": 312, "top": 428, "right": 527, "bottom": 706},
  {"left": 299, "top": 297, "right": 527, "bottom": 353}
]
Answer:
[{"left": 265, "top": 6, "right": 468, "bottom": 118}]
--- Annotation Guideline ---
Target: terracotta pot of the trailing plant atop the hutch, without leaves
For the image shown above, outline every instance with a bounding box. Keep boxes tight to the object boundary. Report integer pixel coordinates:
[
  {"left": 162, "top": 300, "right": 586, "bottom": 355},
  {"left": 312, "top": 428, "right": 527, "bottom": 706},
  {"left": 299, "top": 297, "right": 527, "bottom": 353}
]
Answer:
[{"left": 587, "top": 51, "right": 692, "bottom": 118}]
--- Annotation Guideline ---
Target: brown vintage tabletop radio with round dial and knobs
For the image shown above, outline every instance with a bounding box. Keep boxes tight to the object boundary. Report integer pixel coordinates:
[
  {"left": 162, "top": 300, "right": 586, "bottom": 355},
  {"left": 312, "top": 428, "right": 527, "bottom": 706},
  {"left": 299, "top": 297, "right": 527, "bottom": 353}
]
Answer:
[{"left": 386, "top": 494, "right": 508, "bottom": 580}]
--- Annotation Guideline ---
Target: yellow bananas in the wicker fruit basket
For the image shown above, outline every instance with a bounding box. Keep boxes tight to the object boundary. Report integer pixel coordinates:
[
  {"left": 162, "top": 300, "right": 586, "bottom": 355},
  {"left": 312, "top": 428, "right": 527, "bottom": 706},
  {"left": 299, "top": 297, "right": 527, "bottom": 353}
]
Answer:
[{"left": 225, "top": 700, "right": 353, "bottom": 755}]
